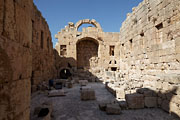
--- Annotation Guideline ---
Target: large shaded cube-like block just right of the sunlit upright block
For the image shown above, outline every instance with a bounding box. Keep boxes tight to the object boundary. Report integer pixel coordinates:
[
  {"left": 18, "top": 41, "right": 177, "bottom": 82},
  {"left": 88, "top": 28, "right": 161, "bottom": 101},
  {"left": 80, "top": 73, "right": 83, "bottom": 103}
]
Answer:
[{"left": 125, "top": 93, "right": 144, "bottom": 109}]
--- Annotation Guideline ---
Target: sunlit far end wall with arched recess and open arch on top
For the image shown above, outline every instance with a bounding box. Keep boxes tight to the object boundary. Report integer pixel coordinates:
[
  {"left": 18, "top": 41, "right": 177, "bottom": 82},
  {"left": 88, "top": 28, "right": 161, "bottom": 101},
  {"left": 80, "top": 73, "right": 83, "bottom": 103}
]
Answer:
[{"left": 55, "top": 19, "right": 120, "bottom": 77}]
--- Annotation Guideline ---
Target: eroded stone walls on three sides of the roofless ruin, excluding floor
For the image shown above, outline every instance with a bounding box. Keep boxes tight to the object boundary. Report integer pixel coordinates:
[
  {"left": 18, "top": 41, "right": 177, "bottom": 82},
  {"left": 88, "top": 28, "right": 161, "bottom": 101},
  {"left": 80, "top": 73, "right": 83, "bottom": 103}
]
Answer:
[{"left": 0, "top": 0, "right": 180, "bottom": 120}]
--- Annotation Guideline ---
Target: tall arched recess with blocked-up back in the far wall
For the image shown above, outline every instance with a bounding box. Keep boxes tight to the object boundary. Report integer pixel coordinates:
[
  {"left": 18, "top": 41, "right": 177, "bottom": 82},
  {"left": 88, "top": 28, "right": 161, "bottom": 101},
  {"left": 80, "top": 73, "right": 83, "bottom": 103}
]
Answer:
[{"left": 76, "top": 38, "right": 99, "bottom": 69}]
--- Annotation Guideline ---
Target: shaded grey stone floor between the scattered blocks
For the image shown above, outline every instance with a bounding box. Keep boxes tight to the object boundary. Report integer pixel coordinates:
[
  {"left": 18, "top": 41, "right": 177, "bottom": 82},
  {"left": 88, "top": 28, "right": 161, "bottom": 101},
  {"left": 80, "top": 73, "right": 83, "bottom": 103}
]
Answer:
[{"left": 31, "top": 83, "right": 179, "bottom": 120}]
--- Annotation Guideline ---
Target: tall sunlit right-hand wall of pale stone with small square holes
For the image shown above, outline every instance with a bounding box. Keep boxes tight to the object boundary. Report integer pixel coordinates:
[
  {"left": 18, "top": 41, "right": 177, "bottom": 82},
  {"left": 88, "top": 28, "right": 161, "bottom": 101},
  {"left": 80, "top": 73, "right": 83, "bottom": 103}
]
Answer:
[{"left": 118, "top": 0, "right": 180, "bottom": 115}]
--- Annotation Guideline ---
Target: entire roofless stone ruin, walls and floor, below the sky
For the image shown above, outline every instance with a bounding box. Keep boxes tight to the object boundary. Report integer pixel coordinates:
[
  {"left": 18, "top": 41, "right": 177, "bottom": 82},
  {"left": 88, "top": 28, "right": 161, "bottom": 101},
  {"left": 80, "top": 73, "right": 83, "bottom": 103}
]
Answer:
[{"left": 0, "top": 0, "right": 180, "bottom": 120}]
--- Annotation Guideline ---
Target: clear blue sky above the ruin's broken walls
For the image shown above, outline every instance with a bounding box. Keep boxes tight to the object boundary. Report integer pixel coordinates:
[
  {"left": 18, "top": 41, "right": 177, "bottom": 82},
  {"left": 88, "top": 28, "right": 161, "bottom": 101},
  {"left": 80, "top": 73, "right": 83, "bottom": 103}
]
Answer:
[{"left": 34, "top": 0, "right": 142, "bottom": 46}]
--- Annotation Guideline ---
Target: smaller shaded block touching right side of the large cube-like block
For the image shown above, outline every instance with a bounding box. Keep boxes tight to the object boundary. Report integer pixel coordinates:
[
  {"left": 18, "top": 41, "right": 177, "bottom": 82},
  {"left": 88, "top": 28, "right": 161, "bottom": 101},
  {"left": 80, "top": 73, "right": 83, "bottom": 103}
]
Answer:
[{"left": 145, "top": 97, "right": 157, "bottom": 108}]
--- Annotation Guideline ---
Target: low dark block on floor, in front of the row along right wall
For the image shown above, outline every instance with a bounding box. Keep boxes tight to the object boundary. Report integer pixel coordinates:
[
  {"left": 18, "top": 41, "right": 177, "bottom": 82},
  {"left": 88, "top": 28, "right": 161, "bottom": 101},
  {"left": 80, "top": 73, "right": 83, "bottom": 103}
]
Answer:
[{"left": 106, "top": 104, "right": 121, "bottom": 115}]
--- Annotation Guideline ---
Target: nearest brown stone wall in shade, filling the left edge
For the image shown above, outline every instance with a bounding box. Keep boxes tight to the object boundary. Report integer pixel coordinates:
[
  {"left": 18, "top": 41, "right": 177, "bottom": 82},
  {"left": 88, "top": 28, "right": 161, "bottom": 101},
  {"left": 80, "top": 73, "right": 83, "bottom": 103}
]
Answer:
[{"left": 0, "top": 0, "right": 33, "bottom": 120}]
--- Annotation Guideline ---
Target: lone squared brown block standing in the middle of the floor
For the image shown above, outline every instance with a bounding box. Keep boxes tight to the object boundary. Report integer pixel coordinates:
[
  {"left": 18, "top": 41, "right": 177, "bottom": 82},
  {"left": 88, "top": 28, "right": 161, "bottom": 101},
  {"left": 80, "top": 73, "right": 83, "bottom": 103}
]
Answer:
[{"left": 81, "top": 89, "right": 96, "bottom": 100}]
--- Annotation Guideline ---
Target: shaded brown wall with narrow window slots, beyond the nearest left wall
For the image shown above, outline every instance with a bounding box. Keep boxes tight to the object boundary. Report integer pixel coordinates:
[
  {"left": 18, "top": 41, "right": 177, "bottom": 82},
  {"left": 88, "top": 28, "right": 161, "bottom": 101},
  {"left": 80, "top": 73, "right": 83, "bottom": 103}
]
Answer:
[{"left": 31, "top": 6, "right": 56, "bottom": 89}]
